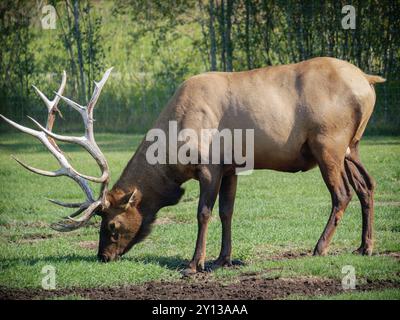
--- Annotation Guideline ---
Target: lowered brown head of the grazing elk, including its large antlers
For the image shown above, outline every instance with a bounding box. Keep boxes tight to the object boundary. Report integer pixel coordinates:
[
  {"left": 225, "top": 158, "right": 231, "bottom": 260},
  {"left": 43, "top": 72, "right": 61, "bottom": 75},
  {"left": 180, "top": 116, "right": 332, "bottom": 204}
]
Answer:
[{"left": 0, "top": 68, "right": 142, "bottom": 261}]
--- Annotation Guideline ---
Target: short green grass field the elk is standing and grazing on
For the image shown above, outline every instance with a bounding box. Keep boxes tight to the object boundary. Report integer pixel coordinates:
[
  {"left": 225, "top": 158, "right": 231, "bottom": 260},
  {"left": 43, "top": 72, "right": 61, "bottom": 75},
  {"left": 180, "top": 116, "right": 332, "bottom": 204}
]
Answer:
[{"left": 0, "top": 134, "right": 400, "bottom": 299}]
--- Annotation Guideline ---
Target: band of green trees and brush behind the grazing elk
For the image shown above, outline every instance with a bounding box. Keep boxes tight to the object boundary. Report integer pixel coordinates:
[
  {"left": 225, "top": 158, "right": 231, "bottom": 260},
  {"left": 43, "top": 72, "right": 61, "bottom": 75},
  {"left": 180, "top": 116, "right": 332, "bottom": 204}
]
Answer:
[{"left": 0, "top": 0, "right": 400, "bottom": 134}]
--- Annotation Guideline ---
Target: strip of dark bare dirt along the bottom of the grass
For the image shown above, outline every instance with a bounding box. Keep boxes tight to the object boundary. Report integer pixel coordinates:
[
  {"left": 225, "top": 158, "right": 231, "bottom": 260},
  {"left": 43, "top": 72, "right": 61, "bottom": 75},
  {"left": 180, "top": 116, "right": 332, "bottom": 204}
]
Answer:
[{"left": 0, "top": 274, "right": 400, "bottom": 300}]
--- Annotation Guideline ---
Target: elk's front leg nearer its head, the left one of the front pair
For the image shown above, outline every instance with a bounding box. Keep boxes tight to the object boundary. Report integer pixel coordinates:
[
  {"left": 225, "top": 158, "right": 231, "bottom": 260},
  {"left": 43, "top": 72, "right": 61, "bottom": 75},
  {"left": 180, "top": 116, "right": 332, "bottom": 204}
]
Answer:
[{"left": 183, "top": 165, "right": 222, "bottom": 275}]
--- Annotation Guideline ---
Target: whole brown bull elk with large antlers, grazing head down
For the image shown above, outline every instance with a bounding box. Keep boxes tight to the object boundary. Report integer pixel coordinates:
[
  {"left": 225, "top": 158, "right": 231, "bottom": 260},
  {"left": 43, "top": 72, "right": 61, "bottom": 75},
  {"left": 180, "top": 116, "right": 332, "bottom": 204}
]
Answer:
[{"left": 1, "top": 58, "right": 385, "bottom": 274}]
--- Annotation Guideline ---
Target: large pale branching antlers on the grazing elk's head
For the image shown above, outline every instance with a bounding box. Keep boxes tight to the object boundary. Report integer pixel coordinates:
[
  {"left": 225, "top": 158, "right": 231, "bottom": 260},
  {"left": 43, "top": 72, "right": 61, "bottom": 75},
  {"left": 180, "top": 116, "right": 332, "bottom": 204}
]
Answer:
[{"left": 0, "top": 68, "right": 112, "bottom": 231}]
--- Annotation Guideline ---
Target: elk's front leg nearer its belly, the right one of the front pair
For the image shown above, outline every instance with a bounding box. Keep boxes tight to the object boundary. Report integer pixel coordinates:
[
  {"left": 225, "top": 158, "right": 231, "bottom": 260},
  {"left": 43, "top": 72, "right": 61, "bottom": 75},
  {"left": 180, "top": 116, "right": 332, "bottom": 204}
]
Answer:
[{"left": 214, "top": 174, "right": 237, "bottom": 267}]
